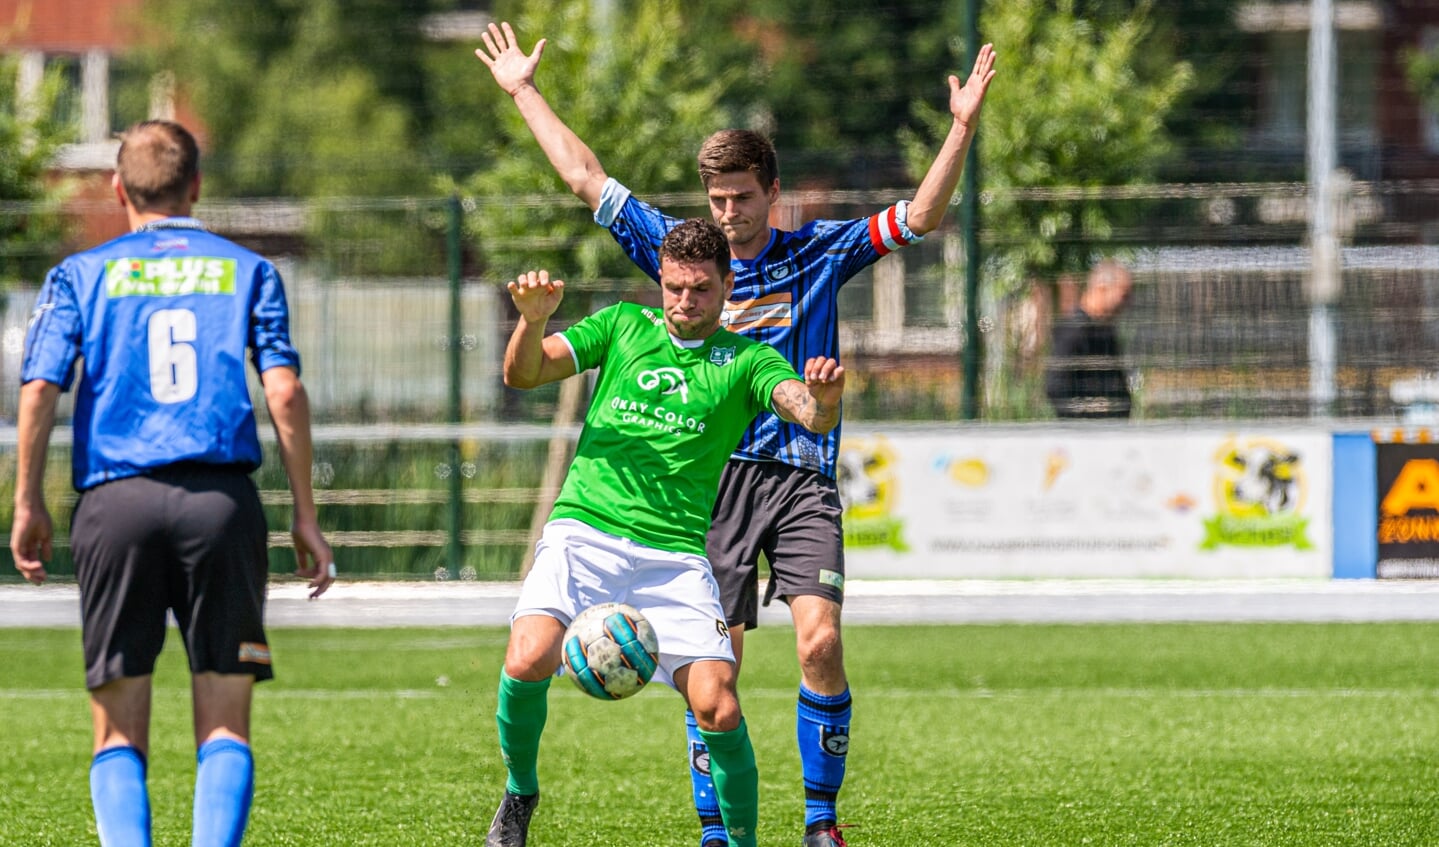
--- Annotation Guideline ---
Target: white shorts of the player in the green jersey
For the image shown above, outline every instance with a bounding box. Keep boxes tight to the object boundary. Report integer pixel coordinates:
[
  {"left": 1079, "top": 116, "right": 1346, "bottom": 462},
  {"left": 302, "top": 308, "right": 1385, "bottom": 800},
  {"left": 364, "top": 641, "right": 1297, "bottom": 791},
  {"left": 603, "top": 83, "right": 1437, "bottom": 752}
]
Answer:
[{"left": 509, "top": 518, "right": 734, "bottom": 686}]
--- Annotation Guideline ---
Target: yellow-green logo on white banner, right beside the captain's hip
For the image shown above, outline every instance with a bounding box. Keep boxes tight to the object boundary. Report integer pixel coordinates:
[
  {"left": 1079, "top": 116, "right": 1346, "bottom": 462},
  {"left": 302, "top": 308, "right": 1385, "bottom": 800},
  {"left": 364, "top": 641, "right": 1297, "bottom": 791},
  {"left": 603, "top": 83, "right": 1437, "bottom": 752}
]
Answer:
[{"left": 835, "top": 437, "right": 909, "bottom": 552}]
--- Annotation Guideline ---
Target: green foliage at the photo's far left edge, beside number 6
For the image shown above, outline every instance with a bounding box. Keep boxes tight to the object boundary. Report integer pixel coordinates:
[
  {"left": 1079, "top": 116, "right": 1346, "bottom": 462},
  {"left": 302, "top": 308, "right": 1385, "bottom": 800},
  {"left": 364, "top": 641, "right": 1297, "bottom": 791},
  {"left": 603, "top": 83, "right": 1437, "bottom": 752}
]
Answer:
[{"left": 0, "top": 56, "right": 72, "bottom": 288}]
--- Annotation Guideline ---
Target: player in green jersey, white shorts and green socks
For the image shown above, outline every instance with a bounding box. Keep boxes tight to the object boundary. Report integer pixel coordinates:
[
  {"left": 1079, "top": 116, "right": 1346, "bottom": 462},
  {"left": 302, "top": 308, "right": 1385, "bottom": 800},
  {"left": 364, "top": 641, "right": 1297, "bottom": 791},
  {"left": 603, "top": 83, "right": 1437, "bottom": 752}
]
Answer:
[{"left": 485, "top": 219, "right": 845, "bottom": 847}]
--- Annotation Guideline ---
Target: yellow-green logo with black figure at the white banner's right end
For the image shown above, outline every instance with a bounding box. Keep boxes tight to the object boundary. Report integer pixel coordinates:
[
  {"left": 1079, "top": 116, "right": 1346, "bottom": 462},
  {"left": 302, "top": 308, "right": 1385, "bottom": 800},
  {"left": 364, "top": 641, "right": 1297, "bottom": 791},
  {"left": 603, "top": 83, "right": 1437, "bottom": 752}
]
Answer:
[{"left": 1200, "top": 437, "right": 1314, "bottom": 551}]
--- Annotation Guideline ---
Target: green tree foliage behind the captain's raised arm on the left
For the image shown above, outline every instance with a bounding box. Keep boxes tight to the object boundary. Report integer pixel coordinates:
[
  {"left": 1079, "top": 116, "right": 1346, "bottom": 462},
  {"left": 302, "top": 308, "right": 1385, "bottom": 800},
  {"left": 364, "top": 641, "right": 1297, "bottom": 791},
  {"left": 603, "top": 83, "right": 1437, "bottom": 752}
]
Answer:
[{"left": 462, "top": 0, "right": 740, "bottom": 286}]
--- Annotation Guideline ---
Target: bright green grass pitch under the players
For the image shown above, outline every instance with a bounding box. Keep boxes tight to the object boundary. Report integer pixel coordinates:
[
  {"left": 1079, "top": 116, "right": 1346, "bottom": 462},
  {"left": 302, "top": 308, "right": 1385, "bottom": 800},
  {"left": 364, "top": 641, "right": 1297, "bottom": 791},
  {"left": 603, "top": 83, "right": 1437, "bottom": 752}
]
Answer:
[{"left": 0, "top": 624, "right": 1439, "bottom": 847}]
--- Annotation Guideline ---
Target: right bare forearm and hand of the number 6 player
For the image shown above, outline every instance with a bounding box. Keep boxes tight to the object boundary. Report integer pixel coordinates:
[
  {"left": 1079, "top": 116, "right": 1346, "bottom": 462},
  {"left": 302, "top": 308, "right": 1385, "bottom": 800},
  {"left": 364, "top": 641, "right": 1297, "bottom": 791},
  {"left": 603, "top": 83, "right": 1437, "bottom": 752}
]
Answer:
[{"left": 260, "top": 365, "right": 335, "bottom": 600}]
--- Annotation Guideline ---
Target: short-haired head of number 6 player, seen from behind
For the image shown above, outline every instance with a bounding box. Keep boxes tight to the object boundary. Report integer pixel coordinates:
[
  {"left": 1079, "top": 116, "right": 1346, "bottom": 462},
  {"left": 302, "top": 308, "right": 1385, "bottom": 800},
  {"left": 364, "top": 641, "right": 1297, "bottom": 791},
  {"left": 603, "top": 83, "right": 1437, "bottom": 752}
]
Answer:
[{"left": 115, "top": 121, "right": 200, "bottom": 211}]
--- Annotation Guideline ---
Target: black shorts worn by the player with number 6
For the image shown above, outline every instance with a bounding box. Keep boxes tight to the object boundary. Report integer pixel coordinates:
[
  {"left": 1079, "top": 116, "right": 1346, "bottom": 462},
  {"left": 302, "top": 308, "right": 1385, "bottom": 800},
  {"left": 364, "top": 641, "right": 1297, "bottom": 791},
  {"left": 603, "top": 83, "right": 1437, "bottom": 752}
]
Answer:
[{"left": 71, "top": 463, "right": 273, "bottom": 689}]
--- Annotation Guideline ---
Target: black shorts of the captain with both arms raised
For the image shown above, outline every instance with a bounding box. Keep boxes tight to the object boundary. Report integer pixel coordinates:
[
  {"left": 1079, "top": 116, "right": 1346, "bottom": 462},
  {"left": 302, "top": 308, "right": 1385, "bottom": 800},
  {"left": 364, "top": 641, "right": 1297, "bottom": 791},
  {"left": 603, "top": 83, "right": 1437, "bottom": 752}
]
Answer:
[{"left": 705, "top": 459, "right": 845, "bottom": 628}]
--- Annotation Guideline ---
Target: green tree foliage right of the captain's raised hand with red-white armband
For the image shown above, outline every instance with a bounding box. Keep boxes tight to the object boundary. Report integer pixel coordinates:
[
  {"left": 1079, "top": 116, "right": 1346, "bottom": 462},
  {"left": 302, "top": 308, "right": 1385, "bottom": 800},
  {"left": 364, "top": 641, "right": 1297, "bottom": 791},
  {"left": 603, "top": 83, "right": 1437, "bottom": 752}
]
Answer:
[{"left": 905, "top": 0, "right": 1193, "bottom": 296}]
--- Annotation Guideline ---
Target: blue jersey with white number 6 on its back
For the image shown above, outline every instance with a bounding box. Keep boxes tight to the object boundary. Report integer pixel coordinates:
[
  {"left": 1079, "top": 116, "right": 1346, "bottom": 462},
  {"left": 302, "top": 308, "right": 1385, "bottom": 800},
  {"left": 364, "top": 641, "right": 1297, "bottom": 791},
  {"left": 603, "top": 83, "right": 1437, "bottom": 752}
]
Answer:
[{"left": 22, "top": 217, "right": 299, "bottom": 490}]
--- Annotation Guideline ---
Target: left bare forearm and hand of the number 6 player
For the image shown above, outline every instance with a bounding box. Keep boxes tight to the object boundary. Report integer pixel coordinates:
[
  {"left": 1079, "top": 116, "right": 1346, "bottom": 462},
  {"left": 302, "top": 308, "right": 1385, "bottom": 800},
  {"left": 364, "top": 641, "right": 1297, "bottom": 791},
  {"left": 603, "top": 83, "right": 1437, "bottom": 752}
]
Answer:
[{"left": 10, "top": 380, "right": 60, "bottom": 585}]
